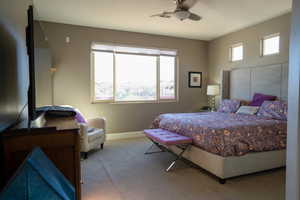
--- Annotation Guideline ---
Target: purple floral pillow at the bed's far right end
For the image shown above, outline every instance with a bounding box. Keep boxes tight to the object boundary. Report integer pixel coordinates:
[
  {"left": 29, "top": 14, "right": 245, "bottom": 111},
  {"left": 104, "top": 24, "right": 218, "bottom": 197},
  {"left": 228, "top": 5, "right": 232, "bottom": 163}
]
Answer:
[{"left": 257, "top": 101, "right": 288, "bottom": 120}]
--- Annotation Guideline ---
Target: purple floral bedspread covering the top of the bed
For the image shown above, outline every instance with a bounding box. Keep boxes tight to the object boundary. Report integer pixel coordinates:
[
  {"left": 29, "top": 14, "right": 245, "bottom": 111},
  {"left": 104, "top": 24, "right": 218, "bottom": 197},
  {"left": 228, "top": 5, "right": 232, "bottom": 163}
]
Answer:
[{"left": 151, "top": 112, "right": 287, "bottom": 157}]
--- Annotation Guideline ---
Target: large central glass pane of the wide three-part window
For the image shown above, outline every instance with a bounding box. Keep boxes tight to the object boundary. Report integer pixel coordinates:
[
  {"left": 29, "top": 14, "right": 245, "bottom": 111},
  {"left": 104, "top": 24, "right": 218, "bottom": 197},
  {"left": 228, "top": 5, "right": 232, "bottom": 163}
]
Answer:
[{"left": 115, "top": 54, "right": 157, "bottom": 101}]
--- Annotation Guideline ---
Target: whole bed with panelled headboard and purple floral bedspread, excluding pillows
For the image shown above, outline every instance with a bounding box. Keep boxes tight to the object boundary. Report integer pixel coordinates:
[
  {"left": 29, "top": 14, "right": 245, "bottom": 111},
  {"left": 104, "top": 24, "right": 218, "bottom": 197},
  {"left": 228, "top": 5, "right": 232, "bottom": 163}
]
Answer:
[{"left": 152, "top": 63, "right": 288, "bottom": 182}]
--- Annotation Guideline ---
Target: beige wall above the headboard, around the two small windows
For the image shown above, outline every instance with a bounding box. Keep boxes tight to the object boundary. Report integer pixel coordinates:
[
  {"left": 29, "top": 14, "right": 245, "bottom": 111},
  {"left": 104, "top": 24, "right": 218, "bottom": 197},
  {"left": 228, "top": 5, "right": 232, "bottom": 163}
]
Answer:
[{"left": 208, "top": 14, "right": 290, "bottom": 84}]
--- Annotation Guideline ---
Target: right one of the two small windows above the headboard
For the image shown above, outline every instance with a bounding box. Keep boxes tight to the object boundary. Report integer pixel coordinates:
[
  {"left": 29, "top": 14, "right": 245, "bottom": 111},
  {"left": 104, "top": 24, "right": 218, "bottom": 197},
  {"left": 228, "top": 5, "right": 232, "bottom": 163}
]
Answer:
[{"left": 261, "top": 33, "right": 280, "bottom": 56}]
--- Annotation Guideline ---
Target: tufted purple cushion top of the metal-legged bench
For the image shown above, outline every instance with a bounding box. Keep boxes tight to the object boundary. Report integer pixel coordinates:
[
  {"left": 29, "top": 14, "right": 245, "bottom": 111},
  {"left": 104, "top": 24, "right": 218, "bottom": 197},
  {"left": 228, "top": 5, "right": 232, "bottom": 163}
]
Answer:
[{"left": 144, "top": 129, "right": 192, "bottom": 145}]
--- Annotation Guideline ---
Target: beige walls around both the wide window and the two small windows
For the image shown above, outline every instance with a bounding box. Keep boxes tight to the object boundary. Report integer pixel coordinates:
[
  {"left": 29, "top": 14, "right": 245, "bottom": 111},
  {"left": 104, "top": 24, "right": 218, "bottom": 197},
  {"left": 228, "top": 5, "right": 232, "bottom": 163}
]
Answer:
[{"left": 39, "top": 14, "right": 290, "bottom": 133}]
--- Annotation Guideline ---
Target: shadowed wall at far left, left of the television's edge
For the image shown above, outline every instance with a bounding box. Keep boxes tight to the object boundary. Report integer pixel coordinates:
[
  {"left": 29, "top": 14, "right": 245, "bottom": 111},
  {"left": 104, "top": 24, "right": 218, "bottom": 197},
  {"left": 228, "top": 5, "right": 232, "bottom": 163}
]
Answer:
[{"left": 0, "top": 4, "right": 36, "bottom": 132}]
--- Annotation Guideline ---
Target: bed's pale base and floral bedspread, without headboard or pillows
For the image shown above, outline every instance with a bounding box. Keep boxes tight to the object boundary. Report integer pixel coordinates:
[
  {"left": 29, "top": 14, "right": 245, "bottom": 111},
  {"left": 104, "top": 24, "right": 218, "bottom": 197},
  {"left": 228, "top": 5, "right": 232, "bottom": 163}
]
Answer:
[{"left": 152, "top": 112, "right": 287, "bottom": 179}]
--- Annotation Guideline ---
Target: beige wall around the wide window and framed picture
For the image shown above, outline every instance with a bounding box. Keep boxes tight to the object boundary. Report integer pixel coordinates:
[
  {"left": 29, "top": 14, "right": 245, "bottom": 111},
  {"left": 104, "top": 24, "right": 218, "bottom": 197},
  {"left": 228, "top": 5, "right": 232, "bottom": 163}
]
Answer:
[{"left": 44, "top": 22, "right": 208, "bottom": 133}]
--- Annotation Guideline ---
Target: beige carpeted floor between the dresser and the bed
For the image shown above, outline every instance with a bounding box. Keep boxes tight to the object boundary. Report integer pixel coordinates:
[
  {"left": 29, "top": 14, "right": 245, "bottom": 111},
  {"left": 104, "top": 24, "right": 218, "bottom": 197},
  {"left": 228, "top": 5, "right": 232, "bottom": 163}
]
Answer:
[{"left": 82, "top": 138, "right": 285, "bottom": 200}]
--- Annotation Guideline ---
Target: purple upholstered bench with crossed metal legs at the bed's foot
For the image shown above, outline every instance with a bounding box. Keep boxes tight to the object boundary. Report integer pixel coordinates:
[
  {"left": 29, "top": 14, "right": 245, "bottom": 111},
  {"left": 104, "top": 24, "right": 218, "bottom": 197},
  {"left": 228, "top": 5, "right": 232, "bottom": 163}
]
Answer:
[{"left": 144, "top": 129, "right": 193, "bottom": 171}]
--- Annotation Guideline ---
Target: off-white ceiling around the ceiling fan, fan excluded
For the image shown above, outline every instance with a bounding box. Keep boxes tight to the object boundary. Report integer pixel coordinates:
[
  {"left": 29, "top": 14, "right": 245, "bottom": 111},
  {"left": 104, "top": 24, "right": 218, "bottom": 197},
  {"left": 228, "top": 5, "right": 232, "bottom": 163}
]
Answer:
[{"left": 34, "top": 0, "right": 292, "bottom": 40}]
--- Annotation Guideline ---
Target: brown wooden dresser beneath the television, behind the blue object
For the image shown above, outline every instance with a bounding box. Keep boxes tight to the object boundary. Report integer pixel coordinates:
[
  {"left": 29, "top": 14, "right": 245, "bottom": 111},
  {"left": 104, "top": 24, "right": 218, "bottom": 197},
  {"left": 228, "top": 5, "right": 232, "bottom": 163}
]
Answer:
[{"left": 0, "top": 117, "right": 81, "bottom": 200}]
